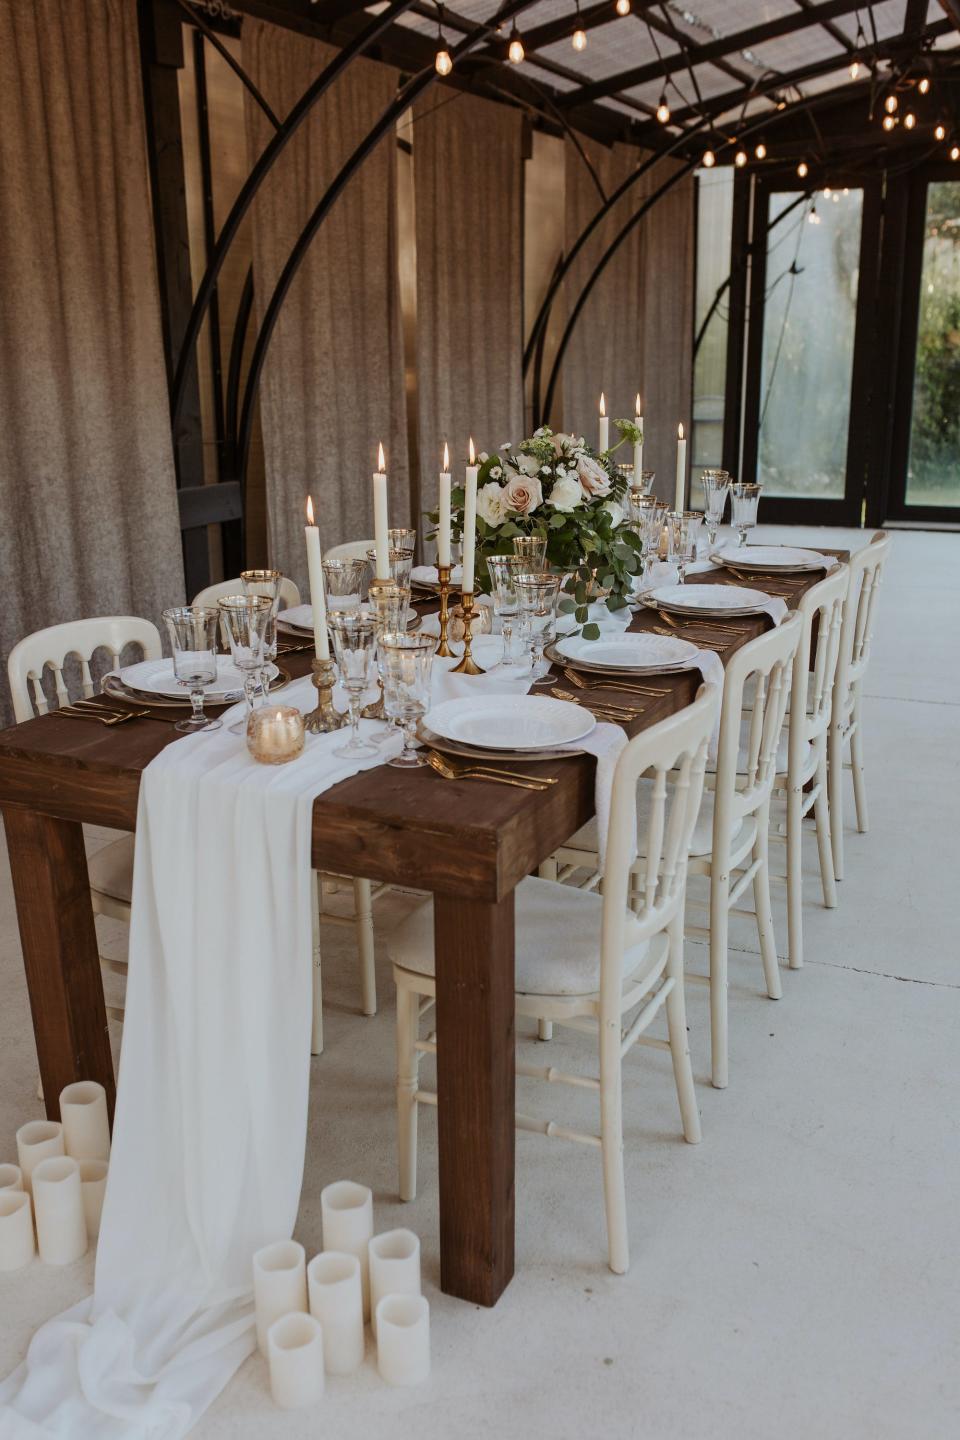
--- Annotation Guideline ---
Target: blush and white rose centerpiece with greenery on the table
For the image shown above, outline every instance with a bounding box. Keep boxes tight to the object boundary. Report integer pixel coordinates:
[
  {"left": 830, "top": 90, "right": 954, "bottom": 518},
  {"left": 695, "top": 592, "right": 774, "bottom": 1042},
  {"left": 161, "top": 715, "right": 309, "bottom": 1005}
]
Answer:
[{"left": 429, "top": 420, "right": 640, "bottom": 639}]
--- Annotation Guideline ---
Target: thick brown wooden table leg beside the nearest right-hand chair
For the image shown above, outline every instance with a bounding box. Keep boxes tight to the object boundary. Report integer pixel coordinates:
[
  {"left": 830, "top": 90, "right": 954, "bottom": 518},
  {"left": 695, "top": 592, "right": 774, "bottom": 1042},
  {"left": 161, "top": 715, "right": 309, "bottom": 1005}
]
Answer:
[{"left": 433, "top": 893, "right": 515, "bottom": 1305}]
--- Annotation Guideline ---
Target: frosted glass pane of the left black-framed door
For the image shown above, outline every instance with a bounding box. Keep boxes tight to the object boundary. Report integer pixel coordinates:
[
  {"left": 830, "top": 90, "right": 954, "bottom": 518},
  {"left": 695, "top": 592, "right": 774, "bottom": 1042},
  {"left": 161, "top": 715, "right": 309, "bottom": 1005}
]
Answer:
[{"left": 757, "top": 190, "right": 864, "bottom": 500}]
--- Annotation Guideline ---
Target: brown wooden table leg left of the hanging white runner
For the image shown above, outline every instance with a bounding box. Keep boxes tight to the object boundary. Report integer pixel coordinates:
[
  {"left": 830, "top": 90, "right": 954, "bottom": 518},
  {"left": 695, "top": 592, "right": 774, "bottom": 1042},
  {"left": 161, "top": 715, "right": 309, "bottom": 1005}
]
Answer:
[{"left": 3, "top": 809, "right": 115, "bottom": 1120}]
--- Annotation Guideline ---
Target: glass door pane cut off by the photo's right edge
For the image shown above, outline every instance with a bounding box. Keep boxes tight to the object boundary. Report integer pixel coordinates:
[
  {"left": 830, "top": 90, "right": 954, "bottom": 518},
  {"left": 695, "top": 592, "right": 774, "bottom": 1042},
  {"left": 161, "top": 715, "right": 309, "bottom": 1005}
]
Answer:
[{"left": 907, "top": 180, "right": 960, "bottom": 505}]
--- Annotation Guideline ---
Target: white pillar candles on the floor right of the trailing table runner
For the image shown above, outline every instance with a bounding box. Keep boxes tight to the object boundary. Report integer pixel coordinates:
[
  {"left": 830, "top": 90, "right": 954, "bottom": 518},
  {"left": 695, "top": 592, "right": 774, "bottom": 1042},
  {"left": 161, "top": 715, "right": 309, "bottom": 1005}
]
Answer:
[{"left": 253, "top": 1181, "right": 430, "bottom": 1410}]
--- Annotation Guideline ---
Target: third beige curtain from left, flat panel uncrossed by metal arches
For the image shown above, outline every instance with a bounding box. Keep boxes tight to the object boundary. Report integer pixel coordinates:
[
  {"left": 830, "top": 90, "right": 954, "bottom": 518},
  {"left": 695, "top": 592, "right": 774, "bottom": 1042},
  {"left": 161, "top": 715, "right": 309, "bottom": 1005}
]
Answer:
[{"left": 413, "top": 86, "right": 524, "bottom": 529}]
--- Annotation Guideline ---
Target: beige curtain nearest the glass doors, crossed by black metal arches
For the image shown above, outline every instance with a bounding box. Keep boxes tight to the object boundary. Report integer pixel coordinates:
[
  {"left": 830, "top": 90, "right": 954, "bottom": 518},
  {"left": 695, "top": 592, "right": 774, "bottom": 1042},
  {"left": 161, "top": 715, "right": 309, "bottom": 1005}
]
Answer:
[{"left": 561, "top": 138, "right": 694, "bottom": 498}]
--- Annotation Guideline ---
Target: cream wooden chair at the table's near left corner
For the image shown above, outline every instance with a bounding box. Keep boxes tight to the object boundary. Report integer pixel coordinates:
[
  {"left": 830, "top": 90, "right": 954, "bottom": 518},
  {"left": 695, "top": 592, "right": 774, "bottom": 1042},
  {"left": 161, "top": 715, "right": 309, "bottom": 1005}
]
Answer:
[{"left": 7, "top": 615, "right": 163, "bottom": 1021}]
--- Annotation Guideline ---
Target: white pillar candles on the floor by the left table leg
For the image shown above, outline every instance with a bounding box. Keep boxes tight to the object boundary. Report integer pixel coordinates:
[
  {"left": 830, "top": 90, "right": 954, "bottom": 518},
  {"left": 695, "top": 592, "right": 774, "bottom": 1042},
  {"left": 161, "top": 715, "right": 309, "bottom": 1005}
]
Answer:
[{"left": 0, "top": 1080, "right": 109, "bottom": 1270}]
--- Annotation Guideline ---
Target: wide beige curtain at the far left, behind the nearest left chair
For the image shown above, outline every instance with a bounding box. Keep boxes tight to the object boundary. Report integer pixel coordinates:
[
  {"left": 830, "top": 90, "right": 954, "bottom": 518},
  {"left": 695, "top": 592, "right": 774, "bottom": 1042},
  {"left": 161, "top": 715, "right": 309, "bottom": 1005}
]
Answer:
[{"left": 0, "top": 0, "right": 183, "bottom": 714}]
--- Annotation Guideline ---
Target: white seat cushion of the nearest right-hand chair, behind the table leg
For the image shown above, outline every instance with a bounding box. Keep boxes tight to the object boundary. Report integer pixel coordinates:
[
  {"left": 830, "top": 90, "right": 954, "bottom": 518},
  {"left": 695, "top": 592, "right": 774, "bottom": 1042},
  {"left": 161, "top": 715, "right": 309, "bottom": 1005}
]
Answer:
[{"left": 387, "top": 878, "right": 649, "bottom": 995}]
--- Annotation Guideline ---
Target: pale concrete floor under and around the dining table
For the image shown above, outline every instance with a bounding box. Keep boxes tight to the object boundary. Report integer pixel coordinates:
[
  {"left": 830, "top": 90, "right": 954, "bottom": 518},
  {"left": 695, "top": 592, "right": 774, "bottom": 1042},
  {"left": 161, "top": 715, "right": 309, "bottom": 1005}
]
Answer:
[{"left": 0, "top": 528, "right": 960, "bottom": 1440}]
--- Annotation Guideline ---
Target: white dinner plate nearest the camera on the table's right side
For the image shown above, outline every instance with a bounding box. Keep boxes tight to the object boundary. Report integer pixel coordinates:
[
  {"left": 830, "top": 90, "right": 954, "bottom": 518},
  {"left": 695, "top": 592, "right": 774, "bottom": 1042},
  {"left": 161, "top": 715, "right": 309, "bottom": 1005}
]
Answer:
[{"left": 423, "top": 696, "right": 596, "bottom": 750}]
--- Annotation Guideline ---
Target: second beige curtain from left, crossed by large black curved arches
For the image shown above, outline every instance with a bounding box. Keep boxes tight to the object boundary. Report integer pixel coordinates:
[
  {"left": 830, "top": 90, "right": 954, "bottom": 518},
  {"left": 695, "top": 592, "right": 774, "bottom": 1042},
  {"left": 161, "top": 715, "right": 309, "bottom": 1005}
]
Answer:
[{"left": 243, "top": 17, "right": 410, "bottom": 589}]
